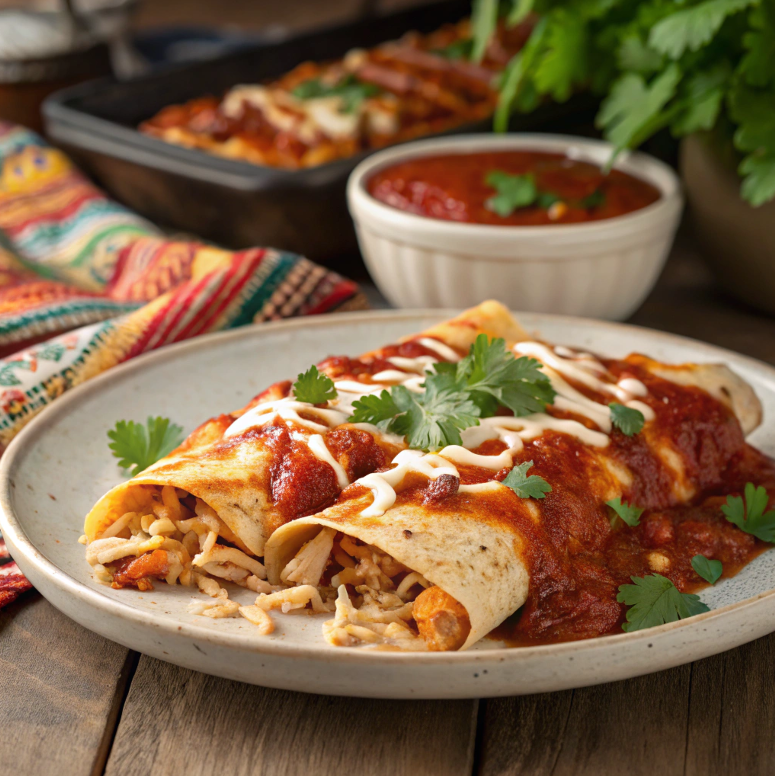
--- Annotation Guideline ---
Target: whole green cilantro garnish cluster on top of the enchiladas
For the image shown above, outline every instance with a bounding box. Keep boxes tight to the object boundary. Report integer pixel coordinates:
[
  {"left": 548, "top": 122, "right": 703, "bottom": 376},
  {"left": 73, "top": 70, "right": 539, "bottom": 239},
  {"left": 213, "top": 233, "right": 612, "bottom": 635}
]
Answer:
[{"left": 350, "top": 334, "right": 555, "bottom": 450}]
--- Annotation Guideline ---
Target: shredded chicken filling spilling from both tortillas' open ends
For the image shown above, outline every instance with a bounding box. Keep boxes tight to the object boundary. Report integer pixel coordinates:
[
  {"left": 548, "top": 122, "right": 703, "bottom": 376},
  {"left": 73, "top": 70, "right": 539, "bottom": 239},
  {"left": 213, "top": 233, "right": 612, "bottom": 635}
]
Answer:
[{"left": 86, "top": 486, "right": 470, "bottom": 650}]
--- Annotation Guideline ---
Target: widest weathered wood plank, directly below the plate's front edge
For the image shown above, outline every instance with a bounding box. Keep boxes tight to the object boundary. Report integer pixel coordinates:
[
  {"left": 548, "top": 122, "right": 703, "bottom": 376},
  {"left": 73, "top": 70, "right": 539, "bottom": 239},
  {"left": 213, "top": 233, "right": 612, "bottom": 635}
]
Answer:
[{"left": 106, "top": 657, "right": 477, "bottom": 776}]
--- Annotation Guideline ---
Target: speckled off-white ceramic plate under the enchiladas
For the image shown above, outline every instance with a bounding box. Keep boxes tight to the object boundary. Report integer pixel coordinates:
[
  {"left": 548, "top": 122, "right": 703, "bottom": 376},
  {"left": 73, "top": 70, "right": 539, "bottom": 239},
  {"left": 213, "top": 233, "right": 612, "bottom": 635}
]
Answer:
[{"left": 0, "top": 311, "right": 775, "bottom": 698}]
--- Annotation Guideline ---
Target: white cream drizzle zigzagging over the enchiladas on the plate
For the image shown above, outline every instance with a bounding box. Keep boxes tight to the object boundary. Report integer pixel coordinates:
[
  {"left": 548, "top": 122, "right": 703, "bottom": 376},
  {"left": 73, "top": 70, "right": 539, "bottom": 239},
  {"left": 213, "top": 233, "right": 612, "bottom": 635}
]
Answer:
[{"left": 220, "top": 337, "right": 655, "bottom": 510}]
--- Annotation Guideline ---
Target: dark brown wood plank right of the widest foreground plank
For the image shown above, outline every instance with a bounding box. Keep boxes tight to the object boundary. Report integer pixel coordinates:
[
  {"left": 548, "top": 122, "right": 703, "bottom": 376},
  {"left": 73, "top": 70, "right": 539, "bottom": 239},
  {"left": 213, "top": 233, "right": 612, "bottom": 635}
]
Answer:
[{"left": 478, "top": 666, "right": 691, "bottom": 776}]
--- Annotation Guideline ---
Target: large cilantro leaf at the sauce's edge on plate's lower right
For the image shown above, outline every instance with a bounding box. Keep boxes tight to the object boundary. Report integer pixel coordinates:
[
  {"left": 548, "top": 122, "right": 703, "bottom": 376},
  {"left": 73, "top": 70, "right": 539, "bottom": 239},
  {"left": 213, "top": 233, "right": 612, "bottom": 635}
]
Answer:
[{"left": 616, "top": 574, "right": 710, "bottom": 633}]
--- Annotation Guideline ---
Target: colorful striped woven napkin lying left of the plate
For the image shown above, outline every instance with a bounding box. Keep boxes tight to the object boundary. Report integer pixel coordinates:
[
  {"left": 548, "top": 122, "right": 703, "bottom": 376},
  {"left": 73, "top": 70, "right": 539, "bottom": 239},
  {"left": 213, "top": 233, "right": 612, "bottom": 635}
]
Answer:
[{"left": 0, "top": 123, "right": 367, "bottom": 608}]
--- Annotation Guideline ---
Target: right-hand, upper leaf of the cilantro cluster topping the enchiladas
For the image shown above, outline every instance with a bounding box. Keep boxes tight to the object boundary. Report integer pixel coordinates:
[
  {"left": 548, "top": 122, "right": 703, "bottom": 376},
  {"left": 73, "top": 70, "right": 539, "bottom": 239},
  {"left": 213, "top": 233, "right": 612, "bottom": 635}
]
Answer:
[{"left": 456, "top": 334, "right": 555, "bottom": 417}]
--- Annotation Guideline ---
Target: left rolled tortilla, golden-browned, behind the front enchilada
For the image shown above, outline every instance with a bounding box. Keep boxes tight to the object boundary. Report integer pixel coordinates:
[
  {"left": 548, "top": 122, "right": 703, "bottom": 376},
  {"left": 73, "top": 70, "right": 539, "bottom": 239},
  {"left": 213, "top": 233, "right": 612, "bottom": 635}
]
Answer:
[{"left": 84, "top": 301, "right": 527, "bottom": 557}]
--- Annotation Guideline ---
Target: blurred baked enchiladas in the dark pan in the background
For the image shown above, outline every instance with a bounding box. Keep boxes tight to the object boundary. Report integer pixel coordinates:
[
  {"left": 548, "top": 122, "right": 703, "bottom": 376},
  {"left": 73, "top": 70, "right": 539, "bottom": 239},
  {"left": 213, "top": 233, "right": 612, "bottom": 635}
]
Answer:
[{"left": 140, "top": 20, "right": 533, "bottom": 169}]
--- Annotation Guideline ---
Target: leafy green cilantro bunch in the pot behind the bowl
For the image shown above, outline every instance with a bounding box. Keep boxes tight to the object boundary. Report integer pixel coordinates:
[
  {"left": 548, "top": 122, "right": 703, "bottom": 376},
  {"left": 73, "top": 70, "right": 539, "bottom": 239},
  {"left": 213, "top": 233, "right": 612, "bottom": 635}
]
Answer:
[{"left": 471, "top": 0, "right": 775, "bottom": 206}]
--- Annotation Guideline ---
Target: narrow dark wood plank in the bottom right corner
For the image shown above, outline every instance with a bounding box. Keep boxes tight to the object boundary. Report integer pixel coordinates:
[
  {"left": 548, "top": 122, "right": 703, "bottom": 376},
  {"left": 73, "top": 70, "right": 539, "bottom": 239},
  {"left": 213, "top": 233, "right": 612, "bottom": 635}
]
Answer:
[{"left": 686, "top": 635, "right": 775, "bottom": 776}]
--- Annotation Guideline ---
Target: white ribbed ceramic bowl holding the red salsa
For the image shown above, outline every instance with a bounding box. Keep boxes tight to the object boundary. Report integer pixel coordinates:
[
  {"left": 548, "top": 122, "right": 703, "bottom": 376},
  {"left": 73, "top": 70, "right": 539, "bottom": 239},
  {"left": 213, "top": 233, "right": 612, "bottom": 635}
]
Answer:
[{"left": 347, "top": 134, "right": 683, "bottom": 320}]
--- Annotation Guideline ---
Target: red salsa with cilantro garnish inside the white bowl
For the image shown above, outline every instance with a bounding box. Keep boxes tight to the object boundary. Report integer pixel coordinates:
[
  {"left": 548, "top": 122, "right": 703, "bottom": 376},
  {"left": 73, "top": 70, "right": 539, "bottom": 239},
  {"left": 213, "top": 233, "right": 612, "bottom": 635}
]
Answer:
[{"left": 367, "top": 151, "right": 661, "bottom": 226}]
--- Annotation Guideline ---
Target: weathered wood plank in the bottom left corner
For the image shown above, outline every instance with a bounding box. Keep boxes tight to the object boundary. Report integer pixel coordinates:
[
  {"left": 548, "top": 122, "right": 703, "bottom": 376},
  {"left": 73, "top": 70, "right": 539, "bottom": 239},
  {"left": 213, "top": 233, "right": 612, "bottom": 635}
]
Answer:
[{"left": 0, "top": 593, "right": 132, "bottom": 776}]
